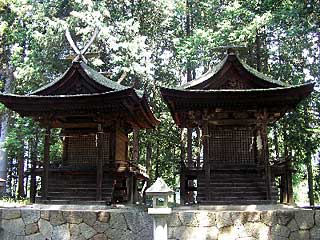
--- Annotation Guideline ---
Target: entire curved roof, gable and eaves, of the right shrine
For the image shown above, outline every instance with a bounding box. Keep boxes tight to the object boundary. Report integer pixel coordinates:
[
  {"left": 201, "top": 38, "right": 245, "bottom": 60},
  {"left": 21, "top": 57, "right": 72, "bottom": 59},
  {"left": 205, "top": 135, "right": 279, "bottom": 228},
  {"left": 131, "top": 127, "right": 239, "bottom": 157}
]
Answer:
[{"left": 160, "top": 49, "right": 314, "bottom": 127}]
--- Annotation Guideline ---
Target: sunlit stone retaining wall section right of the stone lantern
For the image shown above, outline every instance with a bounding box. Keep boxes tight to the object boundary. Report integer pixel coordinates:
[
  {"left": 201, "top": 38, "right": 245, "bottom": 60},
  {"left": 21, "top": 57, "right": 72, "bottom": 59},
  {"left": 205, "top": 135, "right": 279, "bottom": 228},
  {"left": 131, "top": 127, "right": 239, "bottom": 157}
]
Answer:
[{"left": 168, "top": 209, "right": 320, "bottom": 240}]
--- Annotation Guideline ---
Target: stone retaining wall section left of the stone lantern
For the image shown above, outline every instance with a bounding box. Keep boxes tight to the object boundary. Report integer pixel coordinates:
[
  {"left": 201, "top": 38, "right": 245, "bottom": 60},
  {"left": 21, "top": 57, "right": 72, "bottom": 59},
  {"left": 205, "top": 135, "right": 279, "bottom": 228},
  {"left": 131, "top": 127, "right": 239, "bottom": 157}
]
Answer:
[{"left": 0, "top": 208, "right": 152, "bottom": 240}]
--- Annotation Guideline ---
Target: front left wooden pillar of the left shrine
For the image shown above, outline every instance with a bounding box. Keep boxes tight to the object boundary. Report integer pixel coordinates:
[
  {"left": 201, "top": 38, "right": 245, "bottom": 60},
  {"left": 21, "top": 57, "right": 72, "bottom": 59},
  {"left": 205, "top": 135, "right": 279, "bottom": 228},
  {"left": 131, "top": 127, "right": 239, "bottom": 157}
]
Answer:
[{"left": 41, "top": 125, "right": 51, "bottom": 199}]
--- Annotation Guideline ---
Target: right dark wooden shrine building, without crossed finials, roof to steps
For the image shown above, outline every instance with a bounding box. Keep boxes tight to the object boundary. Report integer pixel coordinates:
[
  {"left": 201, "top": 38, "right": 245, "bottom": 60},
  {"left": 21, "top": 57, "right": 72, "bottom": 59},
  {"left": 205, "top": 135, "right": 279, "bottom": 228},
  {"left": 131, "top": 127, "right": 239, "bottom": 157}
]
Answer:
[{"left": 161, "top": 49, "right": 314, "bottom": 204}]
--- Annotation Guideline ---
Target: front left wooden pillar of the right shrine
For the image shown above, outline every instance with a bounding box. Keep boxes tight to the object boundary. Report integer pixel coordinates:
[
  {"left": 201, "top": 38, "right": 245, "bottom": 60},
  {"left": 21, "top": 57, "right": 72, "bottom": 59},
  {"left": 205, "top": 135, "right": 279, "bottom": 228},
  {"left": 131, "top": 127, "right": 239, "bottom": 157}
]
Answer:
[{"left": 202, "top": 116, "right": 210, "bottom": 200}]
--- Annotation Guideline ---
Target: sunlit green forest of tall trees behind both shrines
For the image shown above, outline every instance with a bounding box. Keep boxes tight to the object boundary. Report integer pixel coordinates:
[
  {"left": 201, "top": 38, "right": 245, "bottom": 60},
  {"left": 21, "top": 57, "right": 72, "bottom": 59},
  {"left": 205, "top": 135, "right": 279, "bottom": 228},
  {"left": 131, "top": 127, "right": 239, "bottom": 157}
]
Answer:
[{"left": 0, "top": 0, "right": 320, "bottom": 205}]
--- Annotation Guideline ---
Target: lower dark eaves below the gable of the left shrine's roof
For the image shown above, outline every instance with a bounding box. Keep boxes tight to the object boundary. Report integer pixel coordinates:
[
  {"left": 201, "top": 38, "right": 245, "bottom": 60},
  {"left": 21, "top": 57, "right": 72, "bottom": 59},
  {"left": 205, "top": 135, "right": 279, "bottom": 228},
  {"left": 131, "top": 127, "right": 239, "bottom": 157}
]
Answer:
[{"left": 0, "top": 88, "right": 159, "bottom": 128}]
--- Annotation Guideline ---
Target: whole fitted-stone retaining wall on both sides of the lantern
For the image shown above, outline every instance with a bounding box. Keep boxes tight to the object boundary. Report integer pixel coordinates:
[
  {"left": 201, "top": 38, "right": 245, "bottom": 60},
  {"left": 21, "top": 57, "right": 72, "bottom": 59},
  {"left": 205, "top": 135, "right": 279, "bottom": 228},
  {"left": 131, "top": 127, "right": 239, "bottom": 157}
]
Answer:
[{"left": 0, "top": 205, "right": 320, "bottom": 240}]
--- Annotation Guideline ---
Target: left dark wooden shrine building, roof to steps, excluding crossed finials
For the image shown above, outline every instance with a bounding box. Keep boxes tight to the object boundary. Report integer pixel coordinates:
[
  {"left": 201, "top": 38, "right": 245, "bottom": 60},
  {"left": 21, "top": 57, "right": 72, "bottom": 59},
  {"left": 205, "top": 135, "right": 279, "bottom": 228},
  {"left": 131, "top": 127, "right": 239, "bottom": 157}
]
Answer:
[{"left": 0, "top": 61, "right": 158, "bottom": 203}]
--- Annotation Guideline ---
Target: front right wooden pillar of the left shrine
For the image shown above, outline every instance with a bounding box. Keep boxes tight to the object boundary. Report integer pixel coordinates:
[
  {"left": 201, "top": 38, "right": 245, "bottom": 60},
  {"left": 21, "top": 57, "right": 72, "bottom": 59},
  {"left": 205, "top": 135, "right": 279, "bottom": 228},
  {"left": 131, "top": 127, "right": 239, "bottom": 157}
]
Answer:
[{"left": 96, "top": 124, "right": 103, "bottom": 201}]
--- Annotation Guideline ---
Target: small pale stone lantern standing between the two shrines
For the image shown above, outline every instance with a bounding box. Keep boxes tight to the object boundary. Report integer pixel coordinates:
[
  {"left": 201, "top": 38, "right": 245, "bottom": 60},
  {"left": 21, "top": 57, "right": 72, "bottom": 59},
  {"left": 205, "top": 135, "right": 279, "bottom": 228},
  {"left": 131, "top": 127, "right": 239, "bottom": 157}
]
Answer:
[{"left": 146, "top": 178, "right": 173, "bottom": 240}]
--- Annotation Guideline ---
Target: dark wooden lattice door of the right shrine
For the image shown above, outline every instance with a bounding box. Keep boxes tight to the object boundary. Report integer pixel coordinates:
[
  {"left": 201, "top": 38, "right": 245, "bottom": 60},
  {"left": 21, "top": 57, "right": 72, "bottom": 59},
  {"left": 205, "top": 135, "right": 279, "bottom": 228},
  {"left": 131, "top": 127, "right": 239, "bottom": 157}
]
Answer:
[{"left": 209, "top": 128, "right": 255, "bottom": 165}]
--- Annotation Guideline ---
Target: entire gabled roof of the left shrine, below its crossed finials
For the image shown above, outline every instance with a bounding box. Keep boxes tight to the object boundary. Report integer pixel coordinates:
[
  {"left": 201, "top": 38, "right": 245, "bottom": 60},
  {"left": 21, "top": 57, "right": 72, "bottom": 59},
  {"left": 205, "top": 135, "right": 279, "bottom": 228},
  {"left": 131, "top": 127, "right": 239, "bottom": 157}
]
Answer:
[{"left": 0, "top": 62, "right": 159, "bottom": 128}]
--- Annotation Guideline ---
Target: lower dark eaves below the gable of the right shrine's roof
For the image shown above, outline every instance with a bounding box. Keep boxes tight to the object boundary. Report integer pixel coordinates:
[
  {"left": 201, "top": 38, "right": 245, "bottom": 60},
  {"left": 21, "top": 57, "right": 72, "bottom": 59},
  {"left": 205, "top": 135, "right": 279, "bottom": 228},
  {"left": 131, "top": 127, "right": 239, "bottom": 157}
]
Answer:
[{"left": 161, "top": 83, "right": 314, "bottom": 127}]
